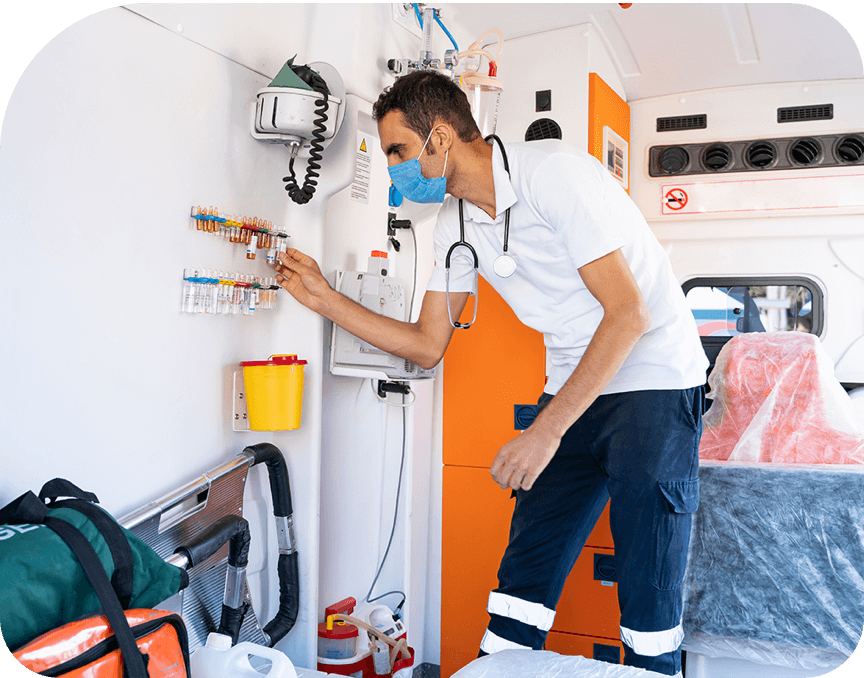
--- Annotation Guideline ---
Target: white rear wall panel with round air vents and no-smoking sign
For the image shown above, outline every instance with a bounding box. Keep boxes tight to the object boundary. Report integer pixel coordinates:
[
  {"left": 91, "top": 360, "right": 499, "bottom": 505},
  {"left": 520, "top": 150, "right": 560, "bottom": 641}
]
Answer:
[{"left": 630, "top": 80, "right": 864, "bottom": 383}]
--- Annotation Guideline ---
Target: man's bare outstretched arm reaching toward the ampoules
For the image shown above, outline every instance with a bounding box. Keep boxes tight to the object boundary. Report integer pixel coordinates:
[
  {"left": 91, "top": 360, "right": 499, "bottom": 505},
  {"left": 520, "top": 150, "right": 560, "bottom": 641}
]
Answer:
[{"left": 276, "top": 249, "right": 469, "bottom": 369}]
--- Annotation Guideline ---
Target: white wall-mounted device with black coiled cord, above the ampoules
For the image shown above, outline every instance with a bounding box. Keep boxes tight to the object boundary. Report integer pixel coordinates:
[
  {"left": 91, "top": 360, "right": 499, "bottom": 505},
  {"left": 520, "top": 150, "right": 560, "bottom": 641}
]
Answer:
[{"left": 250, "top": 61, "right": 345, "bottom": 157}]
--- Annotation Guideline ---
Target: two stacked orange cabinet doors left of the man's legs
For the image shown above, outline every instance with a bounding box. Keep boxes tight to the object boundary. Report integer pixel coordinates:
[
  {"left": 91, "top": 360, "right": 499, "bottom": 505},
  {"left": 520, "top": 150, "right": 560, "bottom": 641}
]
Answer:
[{"left": 441, "top": 278, "right": 545, "bottom": 677}]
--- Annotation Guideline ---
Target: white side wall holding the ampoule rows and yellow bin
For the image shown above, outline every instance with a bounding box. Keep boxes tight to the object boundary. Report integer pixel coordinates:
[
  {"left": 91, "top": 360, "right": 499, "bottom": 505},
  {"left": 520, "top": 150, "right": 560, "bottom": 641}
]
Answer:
[{"left": 0, "top": 8, "right": 322, "bottom": 663}]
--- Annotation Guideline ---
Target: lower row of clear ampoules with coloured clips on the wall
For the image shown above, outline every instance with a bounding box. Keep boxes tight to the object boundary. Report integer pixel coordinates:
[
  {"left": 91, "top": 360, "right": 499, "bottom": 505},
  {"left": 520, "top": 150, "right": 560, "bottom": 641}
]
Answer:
[{"left": 181, "top": 268, "right": 279, "bottom": 315}]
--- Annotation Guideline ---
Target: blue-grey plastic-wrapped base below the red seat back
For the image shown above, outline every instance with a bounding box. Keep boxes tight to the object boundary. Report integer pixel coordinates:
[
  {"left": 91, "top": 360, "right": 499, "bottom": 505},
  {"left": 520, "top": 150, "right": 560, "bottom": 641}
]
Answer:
[{"left": 682, "top": 462, "right": 864, "bottom": 669}]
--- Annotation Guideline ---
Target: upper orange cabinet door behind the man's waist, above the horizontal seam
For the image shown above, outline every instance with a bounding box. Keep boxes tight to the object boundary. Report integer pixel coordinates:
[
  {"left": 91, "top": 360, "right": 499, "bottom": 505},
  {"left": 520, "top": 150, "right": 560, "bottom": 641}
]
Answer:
[{"left": 443, "top": 278, "right": 546, "bottom": 468}]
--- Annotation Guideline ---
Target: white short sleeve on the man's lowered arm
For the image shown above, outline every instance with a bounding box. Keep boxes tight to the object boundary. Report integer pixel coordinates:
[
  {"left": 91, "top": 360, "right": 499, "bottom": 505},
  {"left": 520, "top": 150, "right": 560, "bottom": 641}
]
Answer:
[{"left": 532, "top": 153, "right": 626, "bottom": 268}]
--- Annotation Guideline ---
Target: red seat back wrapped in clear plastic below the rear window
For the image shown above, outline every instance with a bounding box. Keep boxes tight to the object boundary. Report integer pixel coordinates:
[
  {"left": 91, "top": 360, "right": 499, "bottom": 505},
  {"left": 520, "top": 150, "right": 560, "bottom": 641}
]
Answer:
[{"left": 699, "top": 332, "right": 864, "bottom": 464}]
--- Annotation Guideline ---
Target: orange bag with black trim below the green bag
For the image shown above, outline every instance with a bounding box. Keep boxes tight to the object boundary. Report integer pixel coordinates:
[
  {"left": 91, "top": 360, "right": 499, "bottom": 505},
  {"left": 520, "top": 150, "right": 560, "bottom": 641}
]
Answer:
[{"left": 13, "top": 610, "right": 189, "bottom": 678}]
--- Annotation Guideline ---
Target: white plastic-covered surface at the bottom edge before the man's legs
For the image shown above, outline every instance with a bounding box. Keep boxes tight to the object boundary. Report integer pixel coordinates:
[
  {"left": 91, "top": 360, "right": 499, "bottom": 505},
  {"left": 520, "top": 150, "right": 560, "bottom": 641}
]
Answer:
[{"left": 453, "top": 650, "right": 669, "bottom": 678}]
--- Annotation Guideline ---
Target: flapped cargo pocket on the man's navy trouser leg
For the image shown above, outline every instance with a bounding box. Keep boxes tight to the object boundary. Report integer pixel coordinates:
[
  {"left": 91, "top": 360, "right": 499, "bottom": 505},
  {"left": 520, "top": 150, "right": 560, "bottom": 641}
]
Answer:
[{"left": 651, "top": 479, "right": 699, "bottom": 591}]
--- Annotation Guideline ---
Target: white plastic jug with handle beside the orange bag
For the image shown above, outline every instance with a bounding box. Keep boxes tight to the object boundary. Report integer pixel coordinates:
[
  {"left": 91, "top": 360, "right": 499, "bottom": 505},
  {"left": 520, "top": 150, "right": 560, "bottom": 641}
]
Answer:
[{"left": 190, "top": 633, "right": 297, "bottom": 678}]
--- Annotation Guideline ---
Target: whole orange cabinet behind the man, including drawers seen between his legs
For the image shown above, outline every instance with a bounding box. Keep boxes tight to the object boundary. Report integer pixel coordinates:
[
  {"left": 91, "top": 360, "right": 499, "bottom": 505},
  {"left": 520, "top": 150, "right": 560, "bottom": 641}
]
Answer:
[{"left": 441, "top": 278, "right": 620, "bottom": 678}]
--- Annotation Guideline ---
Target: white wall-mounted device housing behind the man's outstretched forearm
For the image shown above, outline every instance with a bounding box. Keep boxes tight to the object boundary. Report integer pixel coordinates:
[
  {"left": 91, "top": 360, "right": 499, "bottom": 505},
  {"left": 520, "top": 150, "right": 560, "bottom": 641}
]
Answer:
[{"left": 330, "top": 271, "right": 435, "bottom": 381}]
